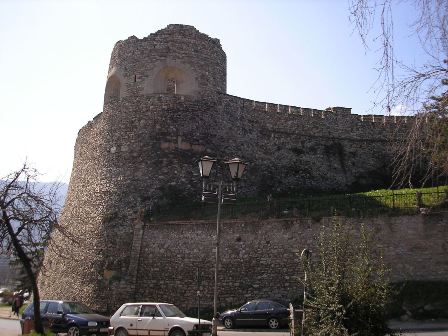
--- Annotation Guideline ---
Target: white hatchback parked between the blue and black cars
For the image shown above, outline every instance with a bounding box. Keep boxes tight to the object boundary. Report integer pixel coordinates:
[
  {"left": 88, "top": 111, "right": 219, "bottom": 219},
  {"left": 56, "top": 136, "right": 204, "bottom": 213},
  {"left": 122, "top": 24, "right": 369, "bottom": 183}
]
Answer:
[{"left": 109, "top": 302, "right": 212, "bottom": 336}]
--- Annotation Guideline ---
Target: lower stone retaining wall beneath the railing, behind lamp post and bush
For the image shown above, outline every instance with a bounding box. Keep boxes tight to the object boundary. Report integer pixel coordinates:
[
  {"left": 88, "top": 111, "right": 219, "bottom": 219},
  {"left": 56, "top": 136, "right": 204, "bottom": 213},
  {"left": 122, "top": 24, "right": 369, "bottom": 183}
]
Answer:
[{"left": 120, "top": 214, "right": 448, "bottom": 311}]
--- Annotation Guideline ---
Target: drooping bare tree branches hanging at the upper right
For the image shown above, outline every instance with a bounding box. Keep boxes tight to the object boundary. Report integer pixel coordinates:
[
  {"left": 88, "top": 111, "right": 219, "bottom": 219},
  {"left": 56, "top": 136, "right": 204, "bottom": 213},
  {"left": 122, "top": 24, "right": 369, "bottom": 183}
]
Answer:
[{"left": 349, "top": 0, "right": 448, "bottom": 186}]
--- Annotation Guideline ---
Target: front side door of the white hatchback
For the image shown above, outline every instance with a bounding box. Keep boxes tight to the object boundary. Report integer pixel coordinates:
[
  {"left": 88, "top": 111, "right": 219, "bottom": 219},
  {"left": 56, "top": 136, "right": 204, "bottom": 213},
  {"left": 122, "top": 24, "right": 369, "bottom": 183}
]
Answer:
[{"left": 137, "top": 304, "right": 169, "bottom": 336}]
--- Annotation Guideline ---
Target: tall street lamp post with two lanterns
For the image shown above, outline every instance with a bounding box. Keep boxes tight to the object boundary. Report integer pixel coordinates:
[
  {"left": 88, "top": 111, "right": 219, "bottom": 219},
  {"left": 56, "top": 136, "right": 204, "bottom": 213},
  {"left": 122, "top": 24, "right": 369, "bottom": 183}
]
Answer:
[{"left": 199, "top": 156, "right": 247, "bottom": 336}]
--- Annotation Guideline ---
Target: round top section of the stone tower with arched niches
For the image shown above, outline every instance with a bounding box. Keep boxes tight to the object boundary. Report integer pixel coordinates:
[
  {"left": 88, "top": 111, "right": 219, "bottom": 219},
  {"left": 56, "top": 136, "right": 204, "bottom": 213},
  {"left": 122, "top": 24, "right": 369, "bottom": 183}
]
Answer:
[{"left": 104, "top": 25, "right": 226, "bottom": 104}]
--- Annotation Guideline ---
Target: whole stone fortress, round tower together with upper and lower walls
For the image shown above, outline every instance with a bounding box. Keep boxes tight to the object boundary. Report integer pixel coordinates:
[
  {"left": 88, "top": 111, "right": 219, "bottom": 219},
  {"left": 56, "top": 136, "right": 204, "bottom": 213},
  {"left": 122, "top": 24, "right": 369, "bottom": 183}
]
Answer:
[{"left": 39, "top": 25, "right": 447, "bottom": 310}]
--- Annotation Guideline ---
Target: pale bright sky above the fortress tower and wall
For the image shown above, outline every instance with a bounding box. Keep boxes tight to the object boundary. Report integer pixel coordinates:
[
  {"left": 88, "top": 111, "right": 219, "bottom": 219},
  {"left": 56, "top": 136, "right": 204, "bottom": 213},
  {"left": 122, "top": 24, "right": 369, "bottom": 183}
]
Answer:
[{"left": 0, "top": 0, "right": 421, "bottom": 182}]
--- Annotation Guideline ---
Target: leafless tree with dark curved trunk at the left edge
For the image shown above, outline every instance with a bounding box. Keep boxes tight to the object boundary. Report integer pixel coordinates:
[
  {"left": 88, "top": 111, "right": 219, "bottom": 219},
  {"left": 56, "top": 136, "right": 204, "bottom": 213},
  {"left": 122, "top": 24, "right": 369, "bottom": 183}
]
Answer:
[{"left": 0, "top": 164, "right": 59, "bottom": 334}]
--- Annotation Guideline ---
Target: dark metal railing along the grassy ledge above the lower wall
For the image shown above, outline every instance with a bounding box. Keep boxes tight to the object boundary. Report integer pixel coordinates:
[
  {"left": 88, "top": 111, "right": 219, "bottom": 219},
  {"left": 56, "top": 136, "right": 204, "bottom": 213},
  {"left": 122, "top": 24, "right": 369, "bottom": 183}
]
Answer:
[{"left": 151, "top": 189, "right": 448, "bottom": 222}]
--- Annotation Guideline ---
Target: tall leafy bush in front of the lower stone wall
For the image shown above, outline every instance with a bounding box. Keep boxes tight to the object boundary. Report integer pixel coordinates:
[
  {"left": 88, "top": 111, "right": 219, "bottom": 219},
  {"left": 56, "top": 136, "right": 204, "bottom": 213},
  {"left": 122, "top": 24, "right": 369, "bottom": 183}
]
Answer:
[{"left": 304, "top": 218, "right": 391, "bottom": 336}]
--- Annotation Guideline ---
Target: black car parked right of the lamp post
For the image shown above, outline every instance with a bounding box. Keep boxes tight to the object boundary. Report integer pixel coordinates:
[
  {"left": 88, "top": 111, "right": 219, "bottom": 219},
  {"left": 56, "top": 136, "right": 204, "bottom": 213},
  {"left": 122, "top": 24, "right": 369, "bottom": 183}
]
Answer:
[{"left": 219, "top": 299, "right": 289, "bottom": 329}]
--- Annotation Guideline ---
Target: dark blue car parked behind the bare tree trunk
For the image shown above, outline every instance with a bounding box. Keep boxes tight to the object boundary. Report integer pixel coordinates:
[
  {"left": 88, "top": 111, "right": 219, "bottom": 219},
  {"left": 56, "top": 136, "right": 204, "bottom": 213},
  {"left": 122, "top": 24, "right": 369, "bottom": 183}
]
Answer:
[{"left": 20, "top": 300, "right": 110, "bottom": 336}]
